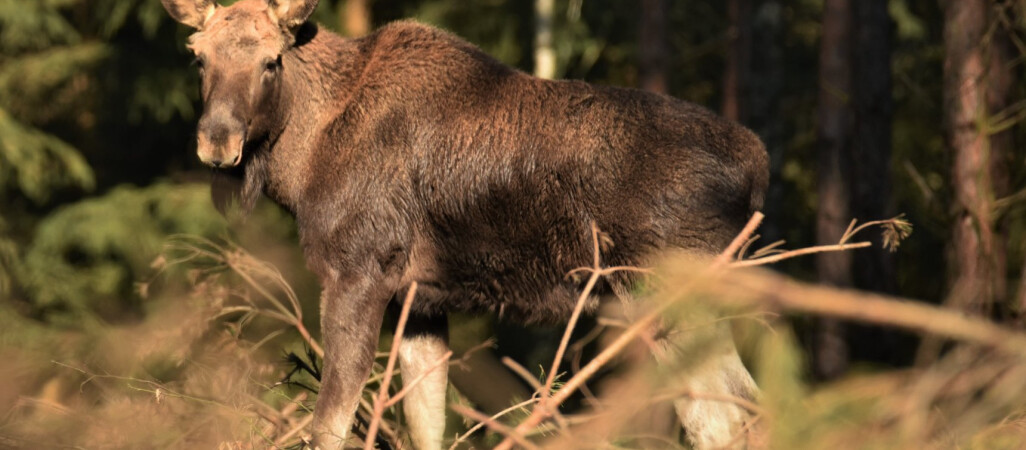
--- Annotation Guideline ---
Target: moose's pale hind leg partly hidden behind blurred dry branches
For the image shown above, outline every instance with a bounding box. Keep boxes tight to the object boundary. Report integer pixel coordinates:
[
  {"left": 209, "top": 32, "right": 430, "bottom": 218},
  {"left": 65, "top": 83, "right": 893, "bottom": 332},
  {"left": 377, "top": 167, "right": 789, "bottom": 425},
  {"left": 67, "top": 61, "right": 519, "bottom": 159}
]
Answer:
[{"left": 656, "top": 323, "right": 758, "bottom": 449}]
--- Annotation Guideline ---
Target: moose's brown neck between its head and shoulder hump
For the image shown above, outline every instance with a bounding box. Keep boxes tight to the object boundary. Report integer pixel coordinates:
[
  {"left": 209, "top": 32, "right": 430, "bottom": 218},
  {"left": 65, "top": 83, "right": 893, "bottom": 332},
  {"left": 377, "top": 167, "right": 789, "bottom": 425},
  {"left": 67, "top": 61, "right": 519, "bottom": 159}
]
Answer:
[{"left": 252, "top": 25, "right": 362, "bottom": 214}]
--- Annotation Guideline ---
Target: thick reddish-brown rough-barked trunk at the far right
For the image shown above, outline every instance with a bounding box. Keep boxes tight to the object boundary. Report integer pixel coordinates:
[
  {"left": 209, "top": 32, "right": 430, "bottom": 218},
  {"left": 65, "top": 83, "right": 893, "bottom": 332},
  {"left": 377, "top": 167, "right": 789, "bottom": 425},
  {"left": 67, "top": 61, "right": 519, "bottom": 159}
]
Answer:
[{"left": 941, "top": 0, "right": 1003, "bottom": 316}]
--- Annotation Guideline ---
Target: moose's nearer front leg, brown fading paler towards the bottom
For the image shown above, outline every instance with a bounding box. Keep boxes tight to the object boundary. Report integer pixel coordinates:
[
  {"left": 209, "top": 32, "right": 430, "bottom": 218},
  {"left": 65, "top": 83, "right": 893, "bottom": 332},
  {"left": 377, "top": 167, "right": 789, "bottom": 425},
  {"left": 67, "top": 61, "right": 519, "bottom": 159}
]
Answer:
[{"left": 313, "top": 277, "right": 394, "bottom": 450}]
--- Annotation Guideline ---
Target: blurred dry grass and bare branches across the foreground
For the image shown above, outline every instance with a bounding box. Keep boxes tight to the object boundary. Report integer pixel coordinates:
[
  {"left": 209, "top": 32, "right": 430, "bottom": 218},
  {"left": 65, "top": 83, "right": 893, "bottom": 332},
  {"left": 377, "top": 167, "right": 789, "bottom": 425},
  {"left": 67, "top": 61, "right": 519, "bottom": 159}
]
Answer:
[{"left": 0, "top": 216, "right": 1026, "bottom": 449}]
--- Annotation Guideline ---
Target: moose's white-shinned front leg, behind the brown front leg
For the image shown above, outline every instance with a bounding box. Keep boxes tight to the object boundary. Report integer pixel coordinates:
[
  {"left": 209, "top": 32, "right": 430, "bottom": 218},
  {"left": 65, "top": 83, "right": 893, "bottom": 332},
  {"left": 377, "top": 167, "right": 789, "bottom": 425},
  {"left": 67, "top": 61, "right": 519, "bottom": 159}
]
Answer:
[{"left": 399, "top": 316, "right": 448, "bottom": 450}]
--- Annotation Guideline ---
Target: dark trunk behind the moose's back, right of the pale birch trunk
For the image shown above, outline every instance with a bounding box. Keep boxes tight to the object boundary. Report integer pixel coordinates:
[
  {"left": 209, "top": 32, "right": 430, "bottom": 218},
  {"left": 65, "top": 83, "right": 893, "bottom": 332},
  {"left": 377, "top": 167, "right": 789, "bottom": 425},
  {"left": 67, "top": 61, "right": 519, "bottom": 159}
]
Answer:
[{"left": 638, "top": 0, "right": 670, "bottom": 93}]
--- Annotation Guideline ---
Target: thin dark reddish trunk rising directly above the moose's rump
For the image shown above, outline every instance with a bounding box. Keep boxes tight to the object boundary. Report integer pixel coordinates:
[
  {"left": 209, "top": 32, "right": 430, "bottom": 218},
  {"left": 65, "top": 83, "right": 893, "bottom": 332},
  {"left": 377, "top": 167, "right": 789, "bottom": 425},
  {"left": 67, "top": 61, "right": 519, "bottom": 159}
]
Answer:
[{"left": 720, "top": 0, "right": 752, "bottom": 123}]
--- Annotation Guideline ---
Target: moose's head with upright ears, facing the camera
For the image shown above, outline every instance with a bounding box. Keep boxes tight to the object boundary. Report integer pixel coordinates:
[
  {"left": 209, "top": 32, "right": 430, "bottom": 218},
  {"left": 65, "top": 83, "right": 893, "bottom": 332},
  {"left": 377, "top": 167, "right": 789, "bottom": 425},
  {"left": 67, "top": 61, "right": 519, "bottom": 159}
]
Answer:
[{"left": 161, "top": 0, "right": 317, "bottom": 168}]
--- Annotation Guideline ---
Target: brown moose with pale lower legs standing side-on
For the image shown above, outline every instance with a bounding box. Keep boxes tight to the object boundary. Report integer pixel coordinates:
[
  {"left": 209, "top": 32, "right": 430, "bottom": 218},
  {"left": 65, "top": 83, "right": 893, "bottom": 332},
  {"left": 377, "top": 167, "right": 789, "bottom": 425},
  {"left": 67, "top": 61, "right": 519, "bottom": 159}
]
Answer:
[{"left": 161, "top": 0, "right": 768, "bottom": 450}]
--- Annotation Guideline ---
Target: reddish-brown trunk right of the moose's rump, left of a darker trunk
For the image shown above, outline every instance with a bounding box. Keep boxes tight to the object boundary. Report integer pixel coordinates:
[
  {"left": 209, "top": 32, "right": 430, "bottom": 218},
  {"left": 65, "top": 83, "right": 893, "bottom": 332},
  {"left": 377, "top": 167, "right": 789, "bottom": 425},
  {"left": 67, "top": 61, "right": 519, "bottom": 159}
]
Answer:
[{"left": 813, "top": 0, "right": 852, "bottom": 378}]
